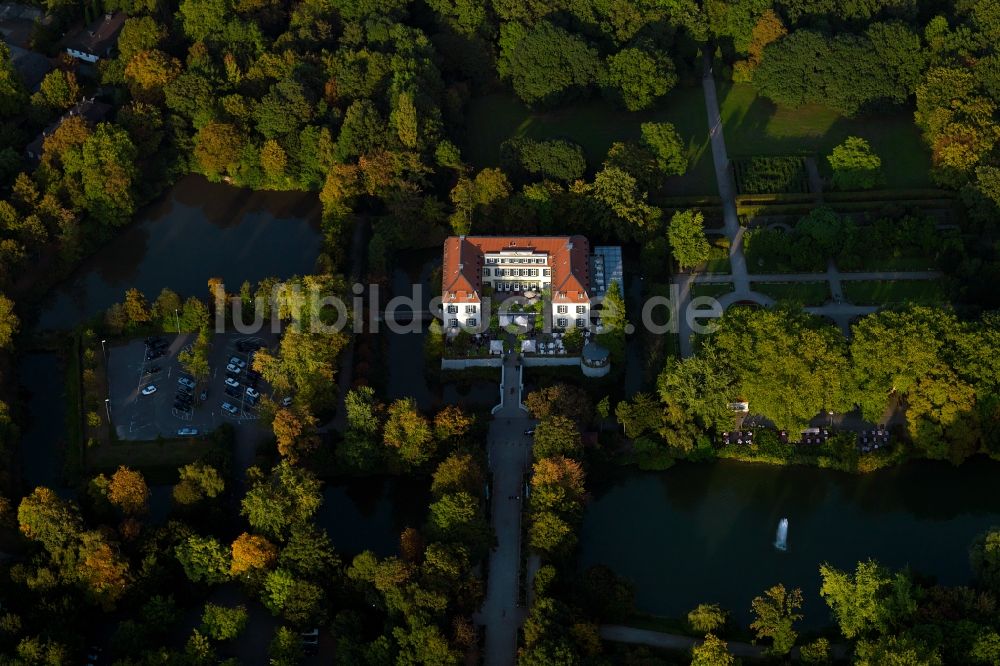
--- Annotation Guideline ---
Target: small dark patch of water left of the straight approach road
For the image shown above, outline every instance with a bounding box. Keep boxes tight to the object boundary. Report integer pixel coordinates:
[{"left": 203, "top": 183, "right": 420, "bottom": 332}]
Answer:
[{"left": 316, "top": 477, "right": 430, "bottom": 561}]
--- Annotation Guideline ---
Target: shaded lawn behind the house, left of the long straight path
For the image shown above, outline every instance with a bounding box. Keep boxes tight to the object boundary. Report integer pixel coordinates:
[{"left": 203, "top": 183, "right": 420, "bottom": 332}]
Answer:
[{"left": 463, "top": 86, "right": 718, "bottom": 196}]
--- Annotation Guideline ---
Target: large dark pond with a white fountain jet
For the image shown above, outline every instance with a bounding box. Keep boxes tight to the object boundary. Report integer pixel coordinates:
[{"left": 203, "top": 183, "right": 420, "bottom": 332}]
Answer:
[{"left": 580, "top": 459, "right": 1000, "bottom": 627}]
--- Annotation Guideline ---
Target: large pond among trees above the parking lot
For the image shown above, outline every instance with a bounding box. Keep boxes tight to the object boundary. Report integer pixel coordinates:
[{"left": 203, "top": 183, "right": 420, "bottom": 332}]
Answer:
[{"left": 38, "top": 176, "right": 322, "bottom": 329}]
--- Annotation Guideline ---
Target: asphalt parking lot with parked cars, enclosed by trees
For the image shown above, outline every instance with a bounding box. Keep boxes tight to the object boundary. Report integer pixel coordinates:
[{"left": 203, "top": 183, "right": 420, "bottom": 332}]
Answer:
[{"left": 108, "top": 334, "right": 276, "bottom": 440}]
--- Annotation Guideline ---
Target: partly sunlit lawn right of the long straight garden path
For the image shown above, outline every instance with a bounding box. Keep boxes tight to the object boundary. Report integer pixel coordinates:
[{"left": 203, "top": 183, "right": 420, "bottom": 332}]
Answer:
[{"left": 719, "top": 84, "right": 931, "bottom": 189}]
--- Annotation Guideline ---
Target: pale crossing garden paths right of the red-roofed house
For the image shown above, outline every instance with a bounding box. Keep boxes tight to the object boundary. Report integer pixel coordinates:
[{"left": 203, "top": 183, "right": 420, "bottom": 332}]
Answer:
[{"left": 674, "top": 49, "right": 941, "bottom": 357}]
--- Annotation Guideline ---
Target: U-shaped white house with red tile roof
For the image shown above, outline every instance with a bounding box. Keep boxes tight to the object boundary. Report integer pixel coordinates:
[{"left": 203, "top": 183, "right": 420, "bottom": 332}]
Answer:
[{"left": 441, "top": 236, "right": 590, "bottom": 328}]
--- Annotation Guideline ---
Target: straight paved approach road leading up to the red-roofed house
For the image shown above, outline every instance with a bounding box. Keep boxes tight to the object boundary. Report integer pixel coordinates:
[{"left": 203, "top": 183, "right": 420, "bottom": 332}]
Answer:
[{"left": 476, "top": 356, "right": 533, "bottom": 666}]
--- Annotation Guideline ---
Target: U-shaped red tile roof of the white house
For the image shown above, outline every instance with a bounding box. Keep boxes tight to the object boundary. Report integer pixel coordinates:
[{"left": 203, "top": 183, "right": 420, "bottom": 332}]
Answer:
[{"left": 441, "top": 236, "right": 590, "bottom": 303}]
